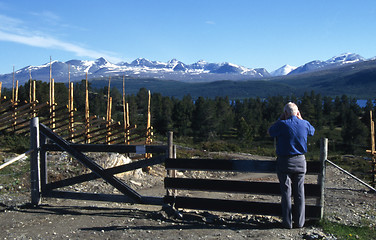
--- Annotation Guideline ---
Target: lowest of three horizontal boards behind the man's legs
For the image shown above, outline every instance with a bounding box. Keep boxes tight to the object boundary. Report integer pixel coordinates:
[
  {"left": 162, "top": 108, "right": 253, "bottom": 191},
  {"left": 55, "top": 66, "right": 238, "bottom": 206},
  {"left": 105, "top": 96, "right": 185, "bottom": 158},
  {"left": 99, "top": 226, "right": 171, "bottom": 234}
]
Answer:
[{"left": 164, "top": 196, "right": 320, "bottom": 219}]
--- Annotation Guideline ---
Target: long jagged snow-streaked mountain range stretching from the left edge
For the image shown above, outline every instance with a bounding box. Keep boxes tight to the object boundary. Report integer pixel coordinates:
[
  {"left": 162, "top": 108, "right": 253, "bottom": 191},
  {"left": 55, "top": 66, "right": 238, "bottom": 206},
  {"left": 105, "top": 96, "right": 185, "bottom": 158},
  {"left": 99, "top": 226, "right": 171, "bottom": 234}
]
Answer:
[{"left": 0, "top": 58, "right": 270, "bottom": 87}]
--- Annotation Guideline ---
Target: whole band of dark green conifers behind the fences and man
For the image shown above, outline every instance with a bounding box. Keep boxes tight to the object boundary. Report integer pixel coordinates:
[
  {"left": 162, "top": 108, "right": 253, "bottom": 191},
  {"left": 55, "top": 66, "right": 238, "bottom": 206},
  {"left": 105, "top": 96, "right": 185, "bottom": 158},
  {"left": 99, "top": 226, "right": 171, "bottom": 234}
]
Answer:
[{"left": 3, "top": 80, "right": 375, "bottom": 152}]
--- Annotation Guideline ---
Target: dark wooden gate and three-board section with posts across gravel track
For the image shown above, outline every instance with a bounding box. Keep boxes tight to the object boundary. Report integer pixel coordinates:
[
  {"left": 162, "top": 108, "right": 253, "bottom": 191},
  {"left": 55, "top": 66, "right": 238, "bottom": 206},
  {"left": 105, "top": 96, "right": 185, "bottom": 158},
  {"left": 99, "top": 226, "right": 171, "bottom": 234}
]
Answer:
[{"left": 30, "top": 121, "right": 328, "bottom": 219}]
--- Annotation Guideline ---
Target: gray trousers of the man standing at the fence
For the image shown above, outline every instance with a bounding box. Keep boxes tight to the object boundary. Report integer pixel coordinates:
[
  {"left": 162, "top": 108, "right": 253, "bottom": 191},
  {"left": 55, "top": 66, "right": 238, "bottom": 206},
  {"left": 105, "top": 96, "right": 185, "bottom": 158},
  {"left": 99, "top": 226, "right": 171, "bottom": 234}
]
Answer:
[{"left": 278, "top": 172, "right": 305, "bottom": 228}]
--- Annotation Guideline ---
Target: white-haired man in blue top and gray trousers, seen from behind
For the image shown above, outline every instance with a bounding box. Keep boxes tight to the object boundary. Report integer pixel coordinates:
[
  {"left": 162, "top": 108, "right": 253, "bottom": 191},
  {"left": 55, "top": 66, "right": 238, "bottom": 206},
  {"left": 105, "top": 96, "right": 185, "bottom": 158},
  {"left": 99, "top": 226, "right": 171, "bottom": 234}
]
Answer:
[{"left": 269, "top": 102, "right": 315, "bottom": 228}]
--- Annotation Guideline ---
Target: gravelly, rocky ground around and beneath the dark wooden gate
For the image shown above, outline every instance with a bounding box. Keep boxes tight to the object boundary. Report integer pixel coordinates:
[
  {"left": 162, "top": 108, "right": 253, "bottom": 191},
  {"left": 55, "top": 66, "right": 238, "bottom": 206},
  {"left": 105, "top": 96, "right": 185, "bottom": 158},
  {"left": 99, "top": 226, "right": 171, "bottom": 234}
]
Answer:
[{"left": 0, "top": 153, "right": 376, "bottom": 239}]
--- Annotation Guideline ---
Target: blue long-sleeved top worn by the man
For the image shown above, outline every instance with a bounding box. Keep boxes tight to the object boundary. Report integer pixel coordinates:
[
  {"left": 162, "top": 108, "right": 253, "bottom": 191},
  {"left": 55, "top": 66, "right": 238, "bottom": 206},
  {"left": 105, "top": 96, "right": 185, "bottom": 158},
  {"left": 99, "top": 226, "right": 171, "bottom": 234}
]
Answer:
[{"left": 269, "top": 116, "right": 315, "bottom": 156}]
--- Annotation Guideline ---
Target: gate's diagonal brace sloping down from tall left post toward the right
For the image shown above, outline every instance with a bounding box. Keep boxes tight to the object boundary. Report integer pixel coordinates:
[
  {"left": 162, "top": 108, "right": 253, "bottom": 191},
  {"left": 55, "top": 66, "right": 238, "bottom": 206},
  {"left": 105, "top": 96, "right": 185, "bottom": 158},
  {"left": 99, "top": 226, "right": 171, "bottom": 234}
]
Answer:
[{"left": 39, "top": 124, "right": 141, "bottom": 202}]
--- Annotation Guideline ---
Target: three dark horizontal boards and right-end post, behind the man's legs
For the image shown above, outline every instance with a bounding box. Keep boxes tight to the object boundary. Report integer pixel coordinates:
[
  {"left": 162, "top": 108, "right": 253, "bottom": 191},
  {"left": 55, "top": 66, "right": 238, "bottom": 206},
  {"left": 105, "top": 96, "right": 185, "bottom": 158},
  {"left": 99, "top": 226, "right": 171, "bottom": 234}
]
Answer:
[{"left": 164, "top": 139, "right": 327, "bottom": 219}]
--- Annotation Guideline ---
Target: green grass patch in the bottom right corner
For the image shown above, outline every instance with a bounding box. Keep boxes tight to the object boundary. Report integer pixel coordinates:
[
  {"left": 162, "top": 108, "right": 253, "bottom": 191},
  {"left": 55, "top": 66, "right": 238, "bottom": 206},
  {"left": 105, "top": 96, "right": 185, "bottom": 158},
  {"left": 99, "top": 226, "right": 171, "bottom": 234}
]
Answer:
[{"left": 319, "top": 220, "right": 376, "bottom": 240}]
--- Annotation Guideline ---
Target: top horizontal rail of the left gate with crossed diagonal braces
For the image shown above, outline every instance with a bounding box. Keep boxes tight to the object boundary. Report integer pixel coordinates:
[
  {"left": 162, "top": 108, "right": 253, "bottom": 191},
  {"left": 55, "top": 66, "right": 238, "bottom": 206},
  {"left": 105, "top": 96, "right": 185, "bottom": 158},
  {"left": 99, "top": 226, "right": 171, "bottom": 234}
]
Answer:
[{"left": 42, "top": 144, "right": 167, "bottom": 153}]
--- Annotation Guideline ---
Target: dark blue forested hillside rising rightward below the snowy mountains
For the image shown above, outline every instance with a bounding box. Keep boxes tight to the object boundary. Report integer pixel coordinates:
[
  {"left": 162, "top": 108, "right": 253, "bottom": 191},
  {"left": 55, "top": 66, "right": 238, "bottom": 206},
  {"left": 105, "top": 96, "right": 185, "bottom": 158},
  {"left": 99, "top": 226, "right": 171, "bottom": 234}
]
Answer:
[{"left": 91, "top": 60, "right": 376, "bottom": 99}]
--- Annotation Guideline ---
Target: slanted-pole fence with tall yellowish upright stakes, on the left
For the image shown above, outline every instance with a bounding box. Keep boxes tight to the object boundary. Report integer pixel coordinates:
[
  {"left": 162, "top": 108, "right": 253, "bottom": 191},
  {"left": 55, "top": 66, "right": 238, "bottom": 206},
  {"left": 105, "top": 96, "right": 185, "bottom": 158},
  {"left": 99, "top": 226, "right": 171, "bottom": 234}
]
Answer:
[{"left": 0, "top": 79, "right": 153, "bottom": 146}]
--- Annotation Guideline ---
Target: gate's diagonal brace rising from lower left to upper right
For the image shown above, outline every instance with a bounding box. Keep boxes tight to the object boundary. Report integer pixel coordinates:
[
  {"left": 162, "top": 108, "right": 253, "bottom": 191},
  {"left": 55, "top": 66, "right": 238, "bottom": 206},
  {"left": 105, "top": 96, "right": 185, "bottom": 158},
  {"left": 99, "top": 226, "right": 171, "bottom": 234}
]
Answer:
[{"left": 46, "top": 156, "right": 165, "bottom": 191}]
